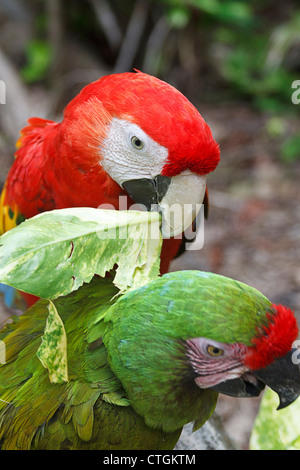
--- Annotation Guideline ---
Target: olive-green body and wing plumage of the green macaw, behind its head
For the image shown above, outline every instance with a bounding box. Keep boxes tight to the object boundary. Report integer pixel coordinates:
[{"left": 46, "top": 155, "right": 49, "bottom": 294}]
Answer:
[{"left": 0, "top": 278, "right": 180, "bottom": 449}]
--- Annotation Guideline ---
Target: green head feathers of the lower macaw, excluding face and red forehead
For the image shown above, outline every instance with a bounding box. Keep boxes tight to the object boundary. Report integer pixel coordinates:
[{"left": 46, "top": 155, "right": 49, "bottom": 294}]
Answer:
[{"left": 104, "top": 271, "right": 271, "bottom": 432}]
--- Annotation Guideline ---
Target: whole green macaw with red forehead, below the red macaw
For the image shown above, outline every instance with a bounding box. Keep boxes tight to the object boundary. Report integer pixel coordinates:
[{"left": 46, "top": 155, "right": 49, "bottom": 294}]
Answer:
[{"left": 0, "top": 271, "right": 300, "bottom": 450}]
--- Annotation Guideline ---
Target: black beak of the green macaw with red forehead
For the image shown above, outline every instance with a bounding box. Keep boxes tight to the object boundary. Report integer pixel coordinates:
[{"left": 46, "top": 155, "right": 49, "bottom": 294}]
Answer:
[{"left": 212, "top": 349, "right": 300, "bottom": 409}]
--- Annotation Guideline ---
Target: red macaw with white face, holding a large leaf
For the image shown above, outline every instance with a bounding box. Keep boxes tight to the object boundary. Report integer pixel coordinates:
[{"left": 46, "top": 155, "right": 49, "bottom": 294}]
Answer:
[{"left": 0, "top": 72, "right": 220, "bottom": 304}]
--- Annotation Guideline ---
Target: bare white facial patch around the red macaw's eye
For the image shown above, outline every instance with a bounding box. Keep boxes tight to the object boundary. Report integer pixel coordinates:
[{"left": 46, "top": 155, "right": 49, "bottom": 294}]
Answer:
[{"left": 100, "top": 118, "right": 168, "bottom": 186}]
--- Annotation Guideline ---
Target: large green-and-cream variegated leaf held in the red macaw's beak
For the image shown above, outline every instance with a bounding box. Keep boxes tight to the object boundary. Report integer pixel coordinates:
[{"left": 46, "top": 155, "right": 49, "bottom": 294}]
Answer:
[{"left": 0, "top": 207, "right": 161, "bottom": 299}]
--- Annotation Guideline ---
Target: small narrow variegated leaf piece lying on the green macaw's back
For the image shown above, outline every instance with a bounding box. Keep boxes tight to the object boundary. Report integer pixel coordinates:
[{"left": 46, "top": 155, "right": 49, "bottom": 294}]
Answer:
[{"left": 36, "top": 301, "right": 68, "bottom": 383}]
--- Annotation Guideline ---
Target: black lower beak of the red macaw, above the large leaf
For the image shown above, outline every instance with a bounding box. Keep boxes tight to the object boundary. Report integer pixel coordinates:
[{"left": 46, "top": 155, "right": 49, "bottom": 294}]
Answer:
[{"left": 122, "top": 175, "right": 171, "bottom": 211}]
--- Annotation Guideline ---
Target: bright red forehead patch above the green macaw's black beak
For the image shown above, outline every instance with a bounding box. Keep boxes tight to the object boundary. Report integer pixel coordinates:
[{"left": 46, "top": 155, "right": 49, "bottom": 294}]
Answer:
[{"left": 245, "top": 304, "right": 298, "bottom": 370}]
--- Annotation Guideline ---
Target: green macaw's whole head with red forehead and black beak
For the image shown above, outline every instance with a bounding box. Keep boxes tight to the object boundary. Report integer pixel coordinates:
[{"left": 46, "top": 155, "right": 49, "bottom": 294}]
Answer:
[{"left": 103, "top": 271, "right": 300, "bottom": 431}]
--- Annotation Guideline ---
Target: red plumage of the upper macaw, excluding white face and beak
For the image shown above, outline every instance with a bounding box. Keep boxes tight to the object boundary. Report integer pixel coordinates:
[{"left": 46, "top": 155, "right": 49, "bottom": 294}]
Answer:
[{"left": 0, "top": 72, "right": 220, "bottom": 306}]
